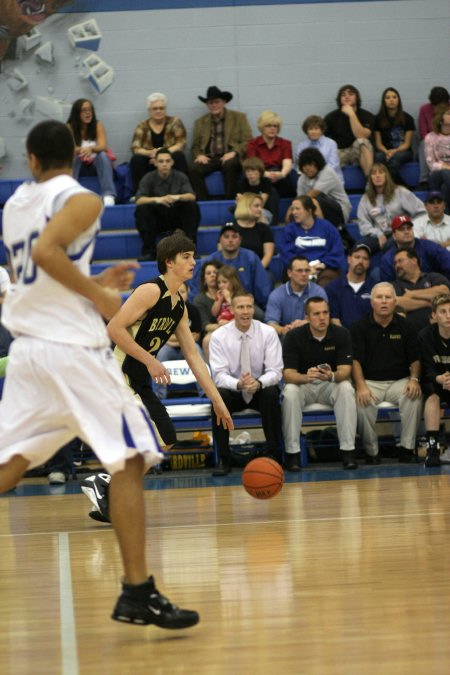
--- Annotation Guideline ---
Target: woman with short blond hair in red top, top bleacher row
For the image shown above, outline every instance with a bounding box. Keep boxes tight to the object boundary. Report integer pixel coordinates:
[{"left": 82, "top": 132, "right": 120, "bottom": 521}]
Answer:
[{"left": 245, "top": 110, "right": 295, "bottom": 197}]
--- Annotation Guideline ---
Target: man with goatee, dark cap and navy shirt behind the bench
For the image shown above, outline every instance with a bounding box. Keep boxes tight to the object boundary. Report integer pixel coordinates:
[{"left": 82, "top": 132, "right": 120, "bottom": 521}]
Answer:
[{"left": 326, "top": 242, "right": 375, "bottom": 328}]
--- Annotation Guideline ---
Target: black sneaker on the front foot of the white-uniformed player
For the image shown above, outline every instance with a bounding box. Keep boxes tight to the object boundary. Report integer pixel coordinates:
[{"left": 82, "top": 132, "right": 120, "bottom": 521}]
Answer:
[{"left": 111, "top": 577, "right": 200, "bottom": 629}]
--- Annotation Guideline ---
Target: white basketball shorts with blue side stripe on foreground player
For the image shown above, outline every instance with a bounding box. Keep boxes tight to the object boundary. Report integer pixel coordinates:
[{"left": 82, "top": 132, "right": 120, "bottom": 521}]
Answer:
[{"left": 0, "top": 336, "right": 162, "bottom": 474}]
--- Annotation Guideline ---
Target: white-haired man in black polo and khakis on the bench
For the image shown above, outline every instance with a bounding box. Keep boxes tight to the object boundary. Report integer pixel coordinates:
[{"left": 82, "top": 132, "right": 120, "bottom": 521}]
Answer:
[{"left": 351, "top": 281, "right": 422, "bottom": 464}]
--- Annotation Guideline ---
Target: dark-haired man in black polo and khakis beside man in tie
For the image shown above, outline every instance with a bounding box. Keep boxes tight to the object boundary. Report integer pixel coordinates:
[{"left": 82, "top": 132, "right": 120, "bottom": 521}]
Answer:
[{"left": 282, "top": 297, "right": 357, "bottom": 471}]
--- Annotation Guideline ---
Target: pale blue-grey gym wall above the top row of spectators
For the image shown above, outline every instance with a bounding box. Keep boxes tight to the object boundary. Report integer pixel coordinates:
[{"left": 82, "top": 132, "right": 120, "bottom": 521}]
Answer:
[{"left": 0, "top": 0, "right": 450, "bottom": 178}]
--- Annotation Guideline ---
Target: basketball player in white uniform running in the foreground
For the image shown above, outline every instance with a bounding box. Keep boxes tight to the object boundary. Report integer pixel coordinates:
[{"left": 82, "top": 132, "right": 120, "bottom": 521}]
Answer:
[{"left": 0, "top": 120, "right": 199, "bottom": 628}]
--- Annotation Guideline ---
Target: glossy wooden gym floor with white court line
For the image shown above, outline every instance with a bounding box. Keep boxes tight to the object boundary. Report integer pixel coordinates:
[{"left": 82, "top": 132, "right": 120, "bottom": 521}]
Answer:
[{"left": 0, "top": 464, "right": 450, "bottom": 675}]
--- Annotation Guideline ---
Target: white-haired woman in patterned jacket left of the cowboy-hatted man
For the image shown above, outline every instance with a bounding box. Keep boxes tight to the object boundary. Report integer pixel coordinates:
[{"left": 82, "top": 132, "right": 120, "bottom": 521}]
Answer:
[{"left": 130, "top": 92, "right": 187, "bottom": 193}]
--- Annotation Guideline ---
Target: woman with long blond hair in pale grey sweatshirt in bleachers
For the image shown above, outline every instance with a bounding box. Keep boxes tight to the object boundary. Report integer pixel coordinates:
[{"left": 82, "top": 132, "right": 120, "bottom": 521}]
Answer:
[{"left": 357, "top": 163, "right": 426, "bottom": 254}]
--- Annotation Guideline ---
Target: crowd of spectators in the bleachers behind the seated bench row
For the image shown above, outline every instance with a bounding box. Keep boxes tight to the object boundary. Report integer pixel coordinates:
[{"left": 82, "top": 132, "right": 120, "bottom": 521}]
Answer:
[{"left": 0, "top": 84, "right": 450, "bottom": 480}]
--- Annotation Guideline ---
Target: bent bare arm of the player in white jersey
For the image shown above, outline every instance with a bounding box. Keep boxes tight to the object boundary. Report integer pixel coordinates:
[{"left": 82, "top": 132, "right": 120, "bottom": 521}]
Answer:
[{"left": 32, "top": 193, "right": 122, "bottom": 319}]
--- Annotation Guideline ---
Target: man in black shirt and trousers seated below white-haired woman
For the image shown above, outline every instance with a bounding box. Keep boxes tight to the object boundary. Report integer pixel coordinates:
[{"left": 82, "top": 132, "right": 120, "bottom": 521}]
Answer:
[{"left": 135, "top": 148, "right": 200, "bottom": 261}]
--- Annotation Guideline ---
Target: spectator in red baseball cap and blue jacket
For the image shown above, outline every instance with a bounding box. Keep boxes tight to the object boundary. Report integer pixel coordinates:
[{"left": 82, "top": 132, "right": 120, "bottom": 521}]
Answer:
[{"left": 380, "top": 216, "right": 450, "bottom": 281}]
